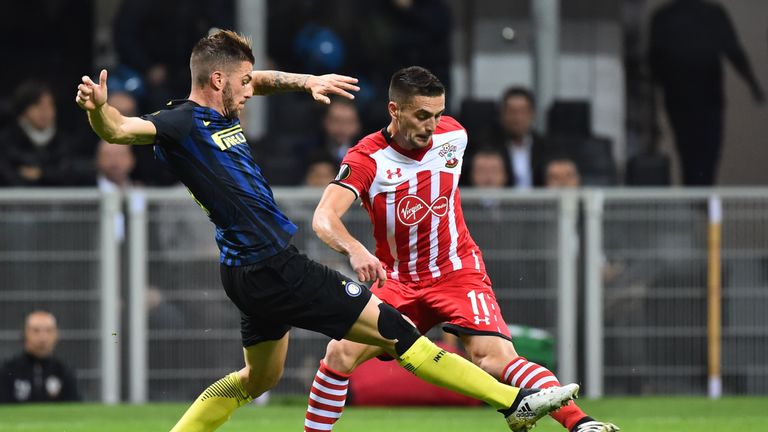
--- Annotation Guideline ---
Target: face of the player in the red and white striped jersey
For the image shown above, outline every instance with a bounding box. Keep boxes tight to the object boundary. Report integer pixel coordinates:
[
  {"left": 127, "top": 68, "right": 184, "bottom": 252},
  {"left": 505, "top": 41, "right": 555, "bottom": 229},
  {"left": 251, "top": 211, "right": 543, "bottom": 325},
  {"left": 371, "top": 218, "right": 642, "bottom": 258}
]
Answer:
[{"left": 391, "top": 95, "right": 445, "bottom": 149}]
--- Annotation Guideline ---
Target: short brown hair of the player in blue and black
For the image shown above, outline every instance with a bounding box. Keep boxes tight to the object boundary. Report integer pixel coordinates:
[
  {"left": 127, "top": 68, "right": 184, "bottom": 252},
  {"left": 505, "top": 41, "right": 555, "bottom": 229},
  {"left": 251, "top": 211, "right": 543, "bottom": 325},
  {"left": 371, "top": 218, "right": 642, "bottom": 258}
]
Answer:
[{"left": 189, "top": 30, "right": 255, "bottom": 87}]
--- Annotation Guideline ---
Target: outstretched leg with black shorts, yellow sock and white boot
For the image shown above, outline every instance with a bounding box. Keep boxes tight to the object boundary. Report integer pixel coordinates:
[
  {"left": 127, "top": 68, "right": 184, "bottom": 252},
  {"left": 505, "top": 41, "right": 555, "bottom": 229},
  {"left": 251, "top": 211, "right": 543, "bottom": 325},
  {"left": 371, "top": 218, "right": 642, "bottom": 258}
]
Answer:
[{"left": 280, "top": 248, "right": 578, "bottom": 430}]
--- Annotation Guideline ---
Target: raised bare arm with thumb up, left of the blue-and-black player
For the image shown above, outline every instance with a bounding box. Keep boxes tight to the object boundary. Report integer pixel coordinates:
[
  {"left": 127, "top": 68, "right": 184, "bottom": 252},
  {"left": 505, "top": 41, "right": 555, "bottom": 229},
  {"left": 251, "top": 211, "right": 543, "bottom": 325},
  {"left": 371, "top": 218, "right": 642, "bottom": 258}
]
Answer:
[{"left": 75, "top": 69, "right": 157, "bottom": 144}]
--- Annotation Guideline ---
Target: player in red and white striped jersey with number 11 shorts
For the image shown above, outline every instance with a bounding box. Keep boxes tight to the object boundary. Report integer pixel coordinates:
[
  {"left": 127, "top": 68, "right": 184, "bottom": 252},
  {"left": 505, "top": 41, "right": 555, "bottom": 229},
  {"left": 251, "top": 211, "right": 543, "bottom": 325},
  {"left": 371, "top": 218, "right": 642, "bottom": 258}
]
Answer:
[{"left": 305, "top": 66, "right": 618, "bottom": 432}]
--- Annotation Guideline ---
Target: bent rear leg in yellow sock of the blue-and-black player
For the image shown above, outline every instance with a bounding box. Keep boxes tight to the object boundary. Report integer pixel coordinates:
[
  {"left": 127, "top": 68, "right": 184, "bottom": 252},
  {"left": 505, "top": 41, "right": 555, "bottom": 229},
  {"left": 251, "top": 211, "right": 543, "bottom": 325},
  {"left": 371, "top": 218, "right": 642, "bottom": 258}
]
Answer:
[{"left": 171, "top": 333, "right": 288, "bottom": 432}]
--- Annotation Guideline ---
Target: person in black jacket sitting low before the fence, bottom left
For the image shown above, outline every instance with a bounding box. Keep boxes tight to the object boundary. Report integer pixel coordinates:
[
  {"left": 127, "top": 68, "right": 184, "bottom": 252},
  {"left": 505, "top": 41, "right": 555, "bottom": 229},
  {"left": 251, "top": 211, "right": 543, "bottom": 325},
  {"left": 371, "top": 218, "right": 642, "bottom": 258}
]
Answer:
[{"left": 0, "top": 310, "right": 80, "bottom": 403}]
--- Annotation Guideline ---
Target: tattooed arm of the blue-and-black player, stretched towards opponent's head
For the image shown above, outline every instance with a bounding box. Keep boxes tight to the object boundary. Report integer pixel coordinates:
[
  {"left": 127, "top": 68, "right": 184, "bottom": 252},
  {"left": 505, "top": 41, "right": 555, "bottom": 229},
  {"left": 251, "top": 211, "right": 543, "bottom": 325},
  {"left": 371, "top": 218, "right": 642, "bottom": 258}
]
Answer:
[{"left": 251, "top": 71, "right": 360, "bottom": 104}]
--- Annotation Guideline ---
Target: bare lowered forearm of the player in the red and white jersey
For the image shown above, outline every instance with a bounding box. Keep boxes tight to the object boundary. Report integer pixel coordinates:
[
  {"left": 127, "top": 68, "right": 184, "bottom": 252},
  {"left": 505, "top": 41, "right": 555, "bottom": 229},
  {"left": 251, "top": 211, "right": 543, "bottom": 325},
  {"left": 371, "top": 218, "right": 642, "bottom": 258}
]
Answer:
[{"left": 312, "top": 183, "right": 387, "bottom": 286}]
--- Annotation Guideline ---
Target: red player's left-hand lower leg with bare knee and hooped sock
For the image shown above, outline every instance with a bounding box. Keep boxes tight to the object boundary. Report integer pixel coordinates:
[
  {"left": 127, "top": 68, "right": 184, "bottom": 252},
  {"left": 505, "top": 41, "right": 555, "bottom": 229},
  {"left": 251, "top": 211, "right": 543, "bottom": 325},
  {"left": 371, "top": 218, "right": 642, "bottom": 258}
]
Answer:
[{"left": 304, "top": 340, "right": 384, "bottom": 432}]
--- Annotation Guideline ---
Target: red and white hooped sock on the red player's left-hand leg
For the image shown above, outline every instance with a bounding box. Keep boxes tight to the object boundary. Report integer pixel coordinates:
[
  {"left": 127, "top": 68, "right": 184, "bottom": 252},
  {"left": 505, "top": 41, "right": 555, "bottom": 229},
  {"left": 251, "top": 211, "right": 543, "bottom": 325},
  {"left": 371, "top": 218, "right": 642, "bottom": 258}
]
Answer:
[{"left": 304, "top": 360, "right": 349, "bottom": 432}]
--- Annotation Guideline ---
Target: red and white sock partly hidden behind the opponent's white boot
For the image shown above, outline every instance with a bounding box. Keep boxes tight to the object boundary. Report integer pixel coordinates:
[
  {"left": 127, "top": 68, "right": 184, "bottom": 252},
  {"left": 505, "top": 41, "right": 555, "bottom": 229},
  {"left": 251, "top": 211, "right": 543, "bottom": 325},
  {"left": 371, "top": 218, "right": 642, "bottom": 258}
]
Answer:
[{"left": 501, "top": 357, "right": 586, "bottom": 430}]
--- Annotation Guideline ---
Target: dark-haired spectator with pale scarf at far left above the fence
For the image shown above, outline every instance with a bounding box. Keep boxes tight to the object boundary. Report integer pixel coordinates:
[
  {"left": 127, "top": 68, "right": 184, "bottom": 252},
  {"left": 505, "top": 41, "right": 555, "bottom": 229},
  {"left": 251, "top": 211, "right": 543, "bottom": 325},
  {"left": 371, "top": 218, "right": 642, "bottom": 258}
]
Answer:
[{"left": 0, "top": 81, "right": 95, "bottom": 186}]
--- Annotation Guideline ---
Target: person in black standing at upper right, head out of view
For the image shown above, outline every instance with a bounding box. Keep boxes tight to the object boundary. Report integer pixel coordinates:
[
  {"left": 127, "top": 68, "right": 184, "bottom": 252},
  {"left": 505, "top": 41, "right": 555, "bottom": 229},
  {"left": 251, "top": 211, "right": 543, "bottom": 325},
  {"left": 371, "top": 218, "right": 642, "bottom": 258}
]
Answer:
[{"left": 649, "top": 0, "right": 765, "bottom": 186}]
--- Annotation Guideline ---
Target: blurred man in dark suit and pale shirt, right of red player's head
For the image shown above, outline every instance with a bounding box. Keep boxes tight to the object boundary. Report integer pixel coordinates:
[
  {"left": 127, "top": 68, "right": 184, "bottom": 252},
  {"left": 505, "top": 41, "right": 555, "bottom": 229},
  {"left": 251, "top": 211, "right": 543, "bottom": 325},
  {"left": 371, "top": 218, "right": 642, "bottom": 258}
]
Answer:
[{"left": 468, "top": 87, "right": 545, "bottom": 189}]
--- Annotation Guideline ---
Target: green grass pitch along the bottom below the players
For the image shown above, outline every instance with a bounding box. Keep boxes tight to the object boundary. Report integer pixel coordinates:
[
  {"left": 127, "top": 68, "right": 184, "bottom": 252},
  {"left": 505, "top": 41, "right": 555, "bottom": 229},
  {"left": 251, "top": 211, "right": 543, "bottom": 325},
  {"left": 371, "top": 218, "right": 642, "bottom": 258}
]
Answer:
[{"left": 0, "top": 397, "right": 768, "bottom": 432}]
